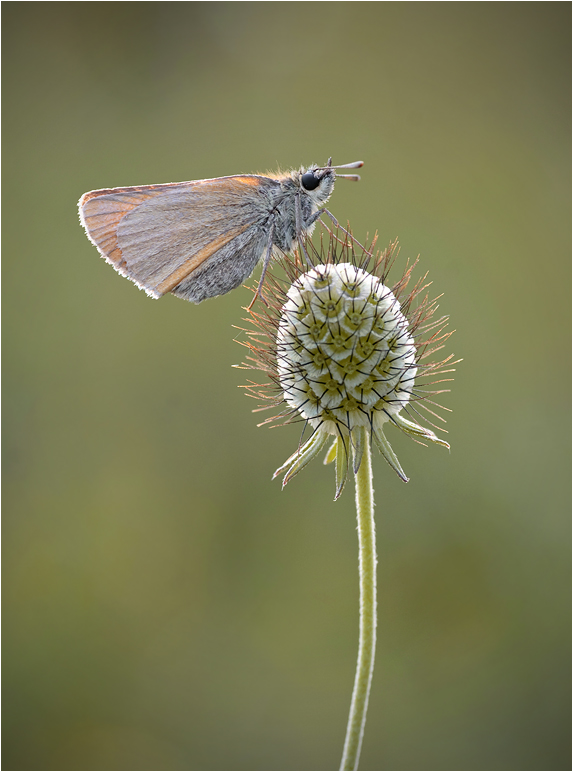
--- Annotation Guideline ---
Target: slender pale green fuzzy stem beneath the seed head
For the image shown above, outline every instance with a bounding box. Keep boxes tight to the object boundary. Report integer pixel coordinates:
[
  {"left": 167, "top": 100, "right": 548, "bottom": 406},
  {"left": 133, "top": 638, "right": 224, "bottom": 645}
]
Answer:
[{"left": 340, "top": 427, "right": 376, "bottom": 770}]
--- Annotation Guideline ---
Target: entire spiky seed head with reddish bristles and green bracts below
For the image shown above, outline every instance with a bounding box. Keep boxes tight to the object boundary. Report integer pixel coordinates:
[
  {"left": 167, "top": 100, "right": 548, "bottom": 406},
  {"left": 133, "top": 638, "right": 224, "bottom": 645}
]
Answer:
[{"left": 239, "top": 229, "right": 453, "bottom": 498}]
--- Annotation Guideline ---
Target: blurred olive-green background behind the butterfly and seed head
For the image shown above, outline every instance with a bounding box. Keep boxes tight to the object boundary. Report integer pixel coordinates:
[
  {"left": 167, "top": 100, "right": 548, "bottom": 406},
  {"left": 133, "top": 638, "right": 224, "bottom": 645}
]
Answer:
[{"left": 2, "top": 2, "right": 571, "bottom": 770}]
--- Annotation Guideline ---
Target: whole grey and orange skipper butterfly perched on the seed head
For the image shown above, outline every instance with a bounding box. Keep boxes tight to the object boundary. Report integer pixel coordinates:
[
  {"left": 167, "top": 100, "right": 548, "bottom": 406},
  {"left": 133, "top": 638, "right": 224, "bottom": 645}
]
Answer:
[{"left": 79, "top": 159, "right": 363, "bottom": 303}]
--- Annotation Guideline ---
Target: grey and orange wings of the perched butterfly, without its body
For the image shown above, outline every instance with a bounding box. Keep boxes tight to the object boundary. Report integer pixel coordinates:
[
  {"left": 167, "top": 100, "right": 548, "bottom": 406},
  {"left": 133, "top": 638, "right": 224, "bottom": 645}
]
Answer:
[{"left": 79, "top": 175, "right": 279, "bottom": 302}]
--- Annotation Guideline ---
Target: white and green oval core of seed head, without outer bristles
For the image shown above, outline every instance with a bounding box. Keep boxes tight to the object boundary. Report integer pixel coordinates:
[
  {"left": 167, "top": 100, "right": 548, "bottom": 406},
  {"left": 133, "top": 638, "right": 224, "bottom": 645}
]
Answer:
[{"left": 277, "top": 263, "right": 417, "bottom": 437}]
